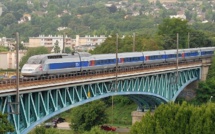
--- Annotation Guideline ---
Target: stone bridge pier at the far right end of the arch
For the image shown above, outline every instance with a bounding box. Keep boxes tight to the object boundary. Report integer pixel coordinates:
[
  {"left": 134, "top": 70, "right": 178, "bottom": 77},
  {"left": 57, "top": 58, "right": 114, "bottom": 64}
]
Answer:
[{"left": 201, "top": 58, "right": 212, "bottom": 81}]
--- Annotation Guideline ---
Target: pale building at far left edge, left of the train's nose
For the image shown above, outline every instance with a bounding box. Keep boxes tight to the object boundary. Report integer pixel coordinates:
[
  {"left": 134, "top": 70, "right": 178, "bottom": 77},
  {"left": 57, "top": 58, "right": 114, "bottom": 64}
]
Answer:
[{"left": 0, "top": 51, "right": 26, "bottom": 69}]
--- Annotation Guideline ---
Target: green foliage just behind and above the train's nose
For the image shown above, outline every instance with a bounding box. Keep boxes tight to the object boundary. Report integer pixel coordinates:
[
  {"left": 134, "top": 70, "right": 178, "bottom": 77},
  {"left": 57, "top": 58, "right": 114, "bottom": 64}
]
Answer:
[{"left": 19, "top": 47, "right": 49, "bottom": 68}]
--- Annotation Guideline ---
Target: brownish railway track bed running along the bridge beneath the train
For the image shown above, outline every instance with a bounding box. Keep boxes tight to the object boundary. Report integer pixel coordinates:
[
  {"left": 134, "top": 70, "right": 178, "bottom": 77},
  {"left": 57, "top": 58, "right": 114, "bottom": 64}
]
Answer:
[{"left": 0, "top": 61, "right": 202, "bottom": 90}]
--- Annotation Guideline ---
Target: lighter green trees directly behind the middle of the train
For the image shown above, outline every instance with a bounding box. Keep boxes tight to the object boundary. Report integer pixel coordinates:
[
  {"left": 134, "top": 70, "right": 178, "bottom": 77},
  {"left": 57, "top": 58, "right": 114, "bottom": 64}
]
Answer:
[{"left": 91, "top": 35, "right": 162, "bottom": 54}]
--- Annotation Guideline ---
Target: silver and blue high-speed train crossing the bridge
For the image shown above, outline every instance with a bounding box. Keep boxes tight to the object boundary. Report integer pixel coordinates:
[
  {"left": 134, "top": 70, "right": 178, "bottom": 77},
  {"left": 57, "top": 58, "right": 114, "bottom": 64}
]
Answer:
[{"left": 21, "top": 47, "right": 215, "bottom": 77}]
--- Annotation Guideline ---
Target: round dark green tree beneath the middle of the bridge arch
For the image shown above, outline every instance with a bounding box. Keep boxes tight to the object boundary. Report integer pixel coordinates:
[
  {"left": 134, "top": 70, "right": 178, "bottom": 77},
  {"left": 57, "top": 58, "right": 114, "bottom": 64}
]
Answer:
[{"left": 70, "top": 100, "right": 107, "bottom": 132}]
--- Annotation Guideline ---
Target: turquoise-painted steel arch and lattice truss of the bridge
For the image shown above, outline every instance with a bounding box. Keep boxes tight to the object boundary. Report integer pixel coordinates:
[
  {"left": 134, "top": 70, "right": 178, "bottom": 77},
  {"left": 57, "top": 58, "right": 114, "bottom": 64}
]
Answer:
[{"left": 0, "top": 67, "right": 201, "bottom": 134}]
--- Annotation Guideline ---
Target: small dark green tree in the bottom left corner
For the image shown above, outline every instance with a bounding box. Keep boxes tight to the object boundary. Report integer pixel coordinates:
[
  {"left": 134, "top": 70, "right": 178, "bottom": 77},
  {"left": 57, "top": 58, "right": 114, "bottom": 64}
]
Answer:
[{"left": 0, "top": 112, "right": 14, "bottom": 134}]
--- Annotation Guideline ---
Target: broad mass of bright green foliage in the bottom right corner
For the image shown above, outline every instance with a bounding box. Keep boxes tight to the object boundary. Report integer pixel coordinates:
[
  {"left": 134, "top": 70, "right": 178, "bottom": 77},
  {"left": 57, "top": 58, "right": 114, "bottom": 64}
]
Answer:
[{"left": 130, "top": 102, "right": 215, "bottom": 134}]
